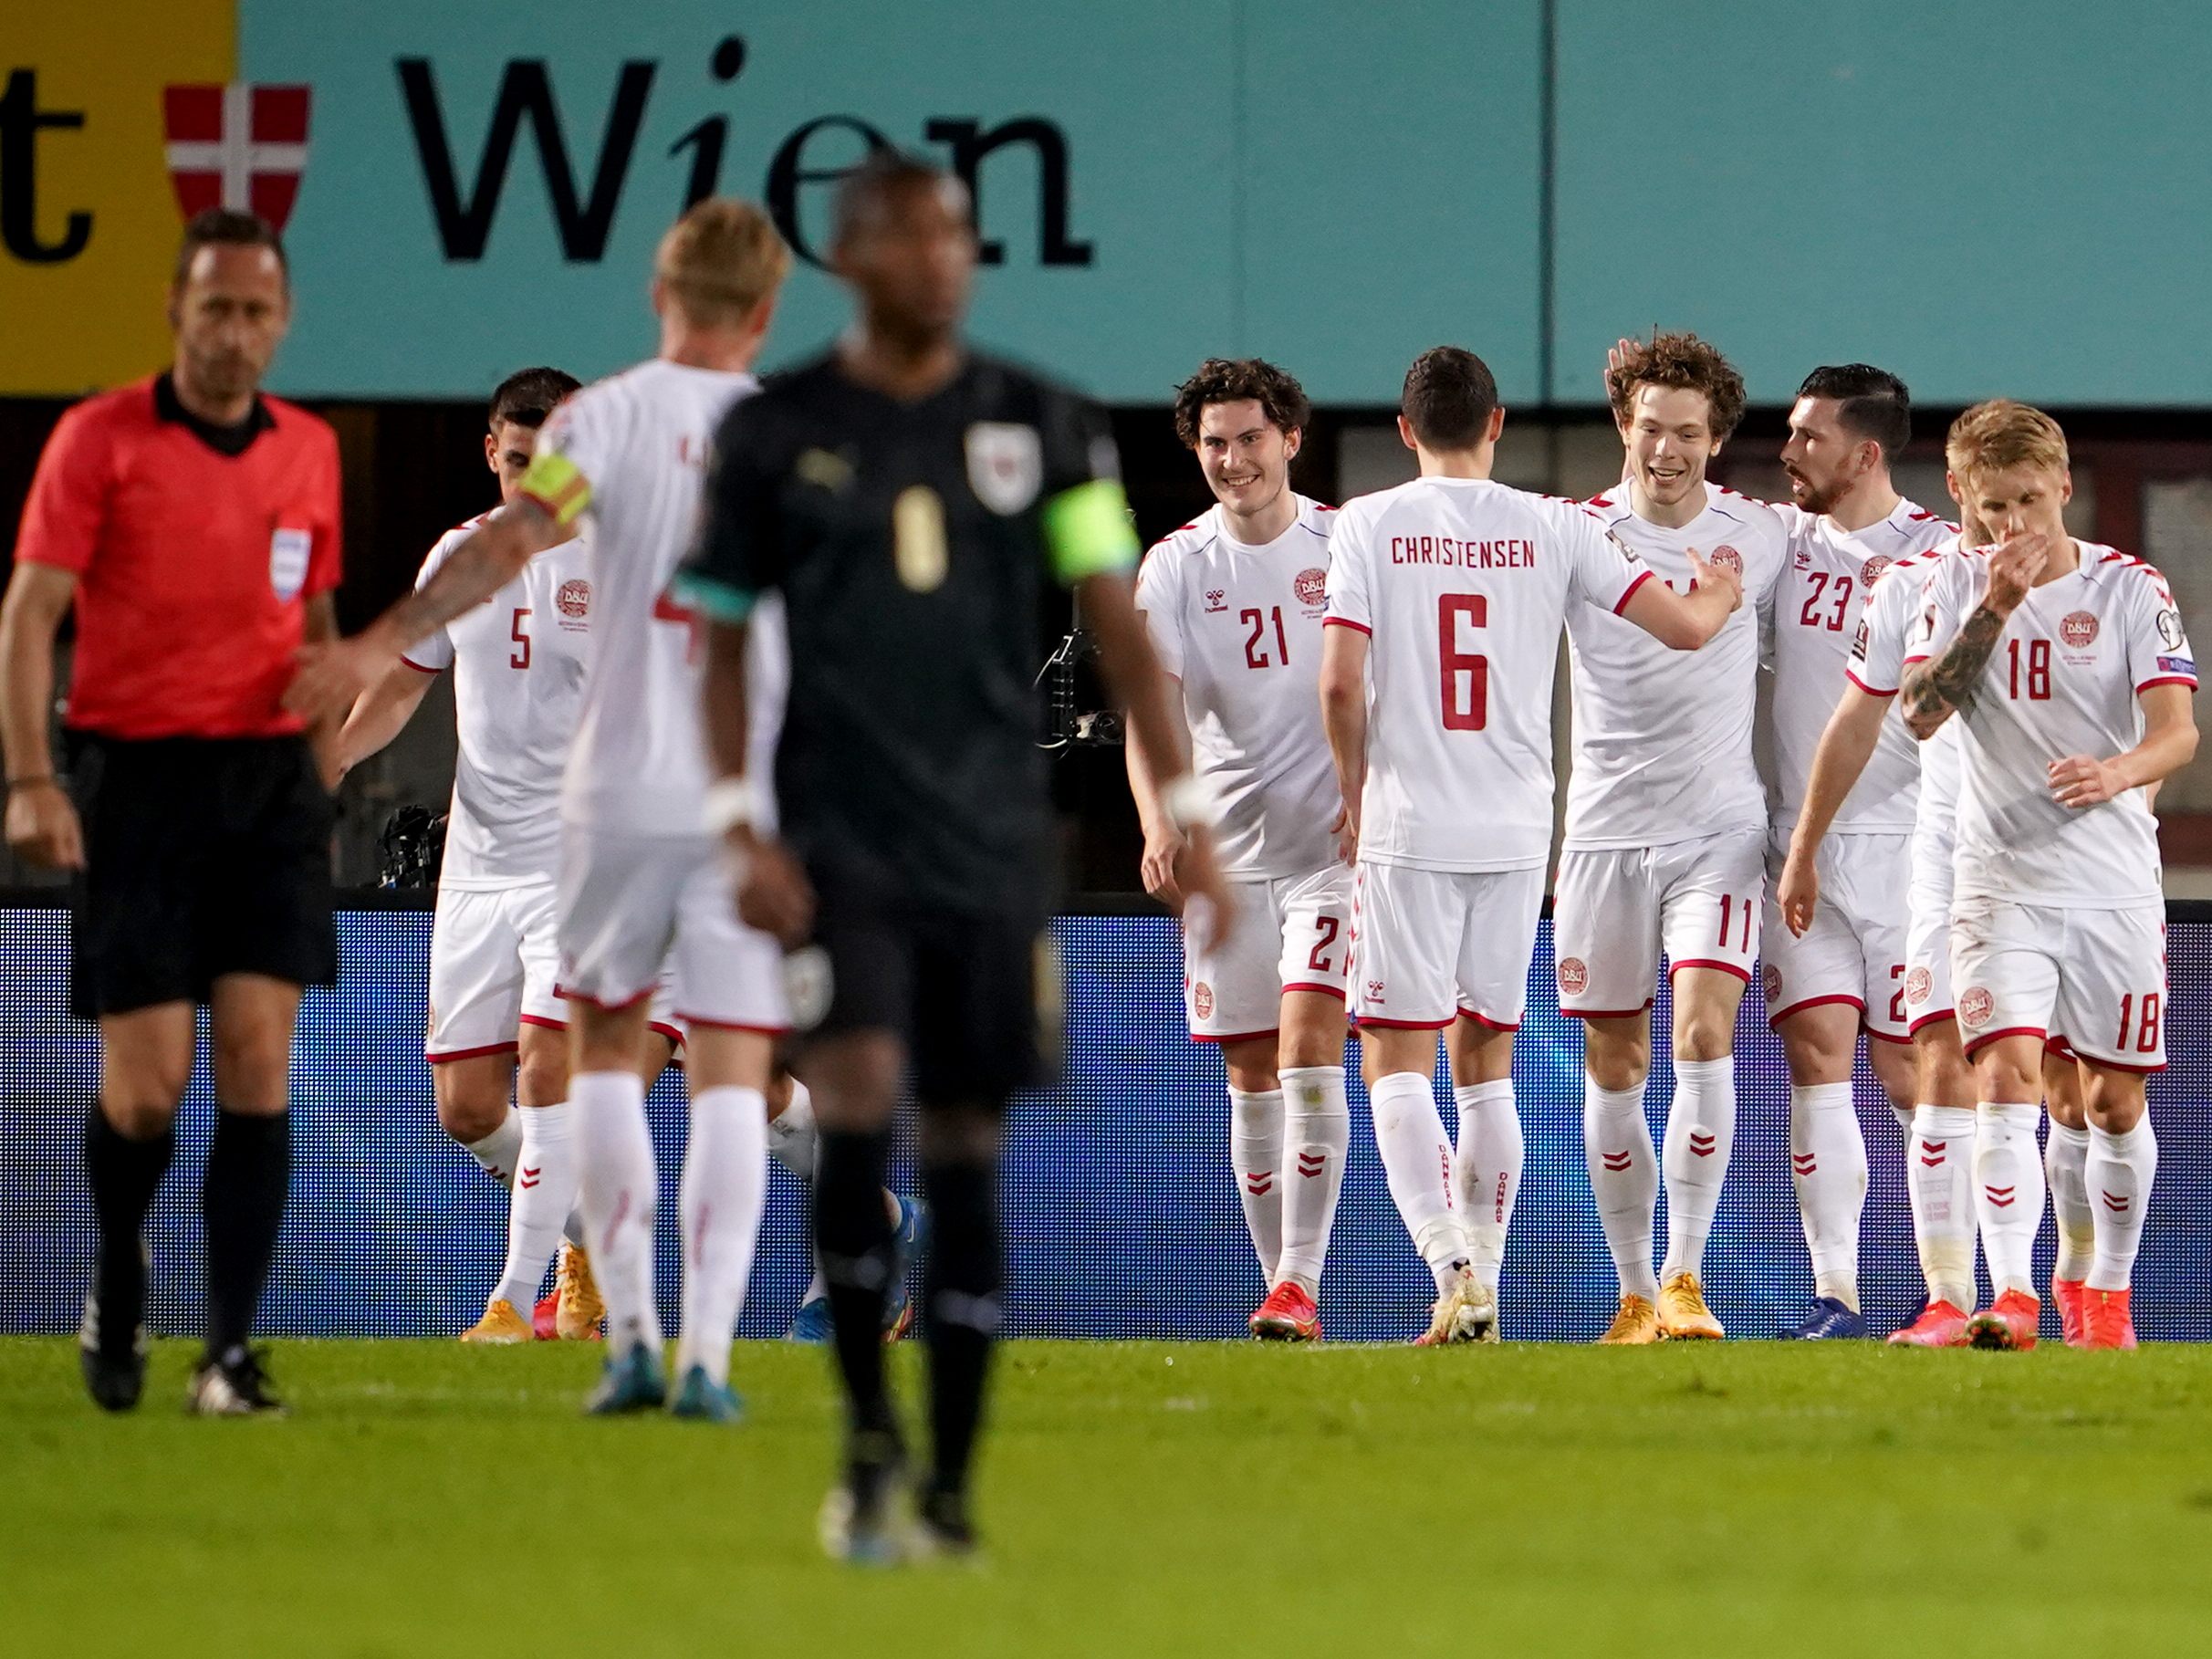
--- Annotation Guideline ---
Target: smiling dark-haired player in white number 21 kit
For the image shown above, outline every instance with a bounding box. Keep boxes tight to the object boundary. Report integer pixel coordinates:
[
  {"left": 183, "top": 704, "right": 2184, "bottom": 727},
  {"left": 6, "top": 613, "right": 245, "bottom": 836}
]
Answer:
[{"left": 1128, "top": 359, "right": 1351, "bottom": 1341}]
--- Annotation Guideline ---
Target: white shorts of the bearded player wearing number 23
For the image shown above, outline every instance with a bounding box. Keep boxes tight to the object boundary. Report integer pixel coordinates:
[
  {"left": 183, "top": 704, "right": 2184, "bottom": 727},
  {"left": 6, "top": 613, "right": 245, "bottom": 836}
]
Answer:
[{"left": 1763, "top": 834, "right": 1914, "bottom": 1042}]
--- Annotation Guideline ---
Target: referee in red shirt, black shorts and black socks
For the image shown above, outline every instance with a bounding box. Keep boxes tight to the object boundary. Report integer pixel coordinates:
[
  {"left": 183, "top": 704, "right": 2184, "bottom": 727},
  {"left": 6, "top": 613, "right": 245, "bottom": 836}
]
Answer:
[{"left": 0, "top": 208, "right": 339, "bottom": 1415}]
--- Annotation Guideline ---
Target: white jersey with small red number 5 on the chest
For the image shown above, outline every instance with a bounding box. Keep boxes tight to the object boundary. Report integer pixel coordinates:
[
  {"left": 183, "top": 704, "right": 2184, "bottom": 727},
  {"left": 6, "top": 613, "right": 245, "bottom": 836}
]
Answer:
[{"left": 407, "top": 513, "right": 593, "bottom": 892}]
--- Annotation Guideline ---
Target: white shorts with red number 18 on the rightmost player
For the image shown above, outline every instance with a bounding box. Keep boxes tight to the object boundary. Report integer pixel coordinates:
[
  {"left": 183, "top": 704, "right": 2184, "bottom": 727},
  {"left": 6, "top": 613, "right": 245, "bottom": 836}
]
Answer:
[{"left": 1951, "top": 898, "right": 2165, "bottom": 1070}]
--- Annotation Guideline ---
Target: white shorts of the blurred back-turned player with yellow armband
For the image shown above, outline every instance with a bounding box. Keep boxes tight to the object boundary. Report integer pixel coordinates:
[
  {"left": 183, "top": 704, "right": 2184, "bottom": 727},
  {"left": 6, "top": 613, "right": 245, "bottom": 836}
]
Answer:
[{"left": 559, "top": 823, "right": 792, "bottom": 1038}]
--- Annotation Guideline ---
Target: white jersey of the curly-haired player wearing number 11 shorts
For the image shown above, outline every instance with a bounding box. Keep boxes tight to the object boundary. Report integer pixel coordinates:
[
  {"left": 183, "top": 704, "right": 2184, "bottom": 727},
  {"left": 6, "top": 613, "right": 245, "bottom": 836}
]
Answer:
[{"left": 1566, "top": 485, "right": 1788, "bottom": 850}]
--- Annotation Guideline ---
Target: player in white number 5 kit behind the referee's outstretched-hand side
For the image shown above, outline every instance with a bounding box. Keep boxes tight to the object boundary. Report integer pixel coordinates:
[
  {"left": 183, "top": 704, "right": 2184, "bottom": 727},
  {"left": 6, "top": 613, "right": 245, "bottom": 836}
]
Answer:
[{"left": 339, "top": 367, "right": 682, "bottom": 1342}]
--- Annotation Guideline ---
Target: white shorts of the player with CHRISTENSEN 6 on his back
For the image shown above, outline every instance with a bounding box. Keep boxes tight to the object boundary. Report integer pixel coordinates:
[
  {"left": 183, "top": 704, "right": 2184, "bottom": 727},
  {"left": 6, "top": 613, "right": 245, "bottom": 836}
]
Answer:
[{"left": 1351, "top": 862, "right": 1544, "bottom": 1031}]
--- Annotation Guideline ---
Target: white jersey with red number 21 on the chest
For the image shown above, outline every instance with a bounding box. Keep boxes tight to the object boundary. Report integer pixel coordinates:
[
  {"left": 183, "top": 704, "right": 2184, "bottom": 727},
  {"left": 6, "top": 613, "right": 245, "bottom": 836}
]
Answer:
[{"left": 1137, "top": 496, "right": 1339, "bottom": 878}]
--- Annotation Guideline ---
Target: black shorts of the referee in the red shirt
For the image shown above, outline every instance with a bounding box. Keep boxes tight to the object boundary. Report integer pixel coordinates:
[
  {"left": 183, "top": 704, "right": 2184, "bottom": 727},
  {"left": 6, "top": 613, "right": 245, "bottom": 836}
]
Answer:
[{"left": 68, "top": 732, "right": 339, "bottom": 1019}]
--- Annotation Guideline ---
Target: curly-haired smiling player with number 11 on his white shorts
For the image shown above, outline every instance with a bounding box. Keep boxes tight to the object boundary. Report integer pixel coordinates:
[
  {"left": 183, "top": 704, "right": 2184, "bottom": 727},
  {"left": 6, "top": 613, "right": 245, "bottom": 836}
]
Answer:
[{"left": 1553, "top": 334, "right": 1785, "bottom": 1342}]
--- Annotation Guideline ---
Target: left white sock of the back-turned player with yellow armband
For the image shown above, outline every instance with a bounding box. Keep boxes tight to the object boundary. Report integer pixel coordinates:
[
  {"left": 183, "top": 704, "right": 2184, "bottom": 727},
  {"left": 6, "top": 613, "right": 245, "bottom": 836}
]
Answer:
[{"left": 569, "top": 1070, "right": 662, "bottom": 1353}]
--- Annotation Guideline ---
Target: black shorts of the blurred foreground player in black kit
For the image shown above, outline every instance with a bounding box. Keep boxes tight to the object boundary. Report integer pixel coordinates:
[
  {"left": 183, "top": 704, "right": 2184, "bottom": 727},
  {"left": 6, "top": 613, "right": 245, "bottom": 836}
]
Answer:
[{"left": 812, "top": 885, "right": 1066, "bottom": 1108}]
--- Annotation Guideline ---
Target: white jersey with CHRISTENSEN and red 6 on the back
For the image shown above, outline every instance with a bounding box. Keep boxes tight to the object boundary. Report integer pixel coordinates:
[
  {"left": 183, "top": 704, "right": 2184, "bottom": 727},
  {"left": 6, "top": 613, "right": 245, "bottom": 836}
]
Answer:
[{"left": 1327, "top": 478, "right": 1653, "bottom": 870}]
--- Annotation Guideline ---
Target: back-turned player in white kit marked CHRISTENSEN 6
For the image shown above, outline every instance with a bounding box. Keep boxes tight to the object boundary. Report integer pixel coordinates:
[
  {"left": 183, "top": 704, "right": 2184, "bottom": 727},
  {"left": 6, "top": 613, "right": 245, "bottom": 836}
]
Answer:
[{"left": 1320, "top": 345, "right": 1743, "bottom": 1342}]
